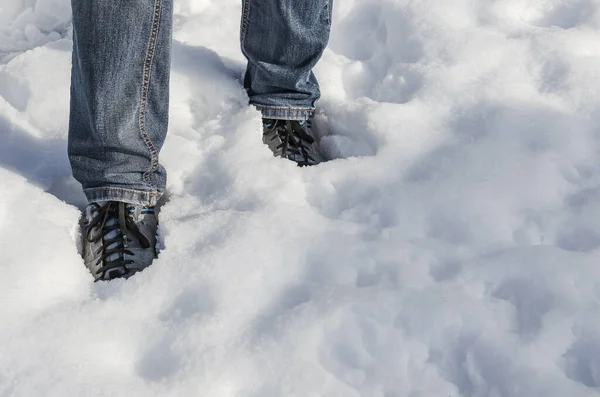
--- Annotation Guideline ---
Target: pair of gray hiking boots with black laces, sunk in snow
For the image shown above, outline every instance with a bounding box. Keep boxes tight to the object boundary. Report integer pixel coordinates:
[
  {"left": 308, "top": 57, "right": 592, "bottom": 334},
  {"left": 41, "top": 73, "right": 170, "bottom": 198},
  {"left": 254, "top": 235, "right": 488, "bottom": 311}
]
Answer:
[{"left": 83, "top": 119, "right": 322, "bottom": 281}]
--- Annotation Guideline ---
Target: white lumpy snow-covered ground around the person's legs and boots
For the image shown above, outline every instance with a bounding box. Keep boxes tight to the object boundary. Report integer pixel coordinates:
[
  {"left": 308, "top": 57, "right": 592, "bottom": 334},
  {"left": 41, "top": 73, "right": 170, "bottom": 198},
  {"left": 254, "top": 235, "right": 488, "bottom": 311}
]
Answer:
[{"left": 0, "top": 0, "right": 600, "bottom": 397}]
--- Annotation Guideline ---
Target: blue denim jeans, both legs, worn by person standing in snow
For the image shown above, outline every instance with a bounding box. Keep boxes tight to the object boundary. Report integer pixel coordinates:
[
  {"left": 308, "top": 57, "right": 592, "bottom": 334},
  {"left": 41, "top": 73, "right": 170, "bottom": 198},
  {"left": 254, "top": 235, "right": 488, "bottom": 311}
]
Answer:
[{"left": 68, "top": 0, "right": 333, "bottom": 206}]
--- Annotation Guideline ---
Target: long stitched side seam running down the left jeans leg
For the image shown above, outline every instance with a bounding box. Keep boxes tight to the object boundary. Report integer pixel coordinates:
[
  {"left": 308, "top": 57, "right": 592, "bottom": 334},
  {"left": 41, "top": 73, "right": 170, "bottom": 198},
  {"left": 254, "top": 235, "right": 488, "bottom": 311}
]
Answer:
[{"left": 138, "top": 0, "right": 162, "bottom": 190}]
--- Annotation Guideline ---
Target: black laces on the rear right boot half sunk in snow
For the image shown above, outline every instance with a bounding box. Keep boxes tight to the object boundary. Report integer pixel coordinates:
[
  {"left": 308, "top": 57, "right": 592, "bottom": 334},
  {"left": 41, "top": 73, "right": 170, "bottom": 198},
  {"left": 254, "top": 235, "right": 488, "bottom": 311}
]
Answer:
[{"left": 265, "top": 120, "right": 317, "bottom": 166}]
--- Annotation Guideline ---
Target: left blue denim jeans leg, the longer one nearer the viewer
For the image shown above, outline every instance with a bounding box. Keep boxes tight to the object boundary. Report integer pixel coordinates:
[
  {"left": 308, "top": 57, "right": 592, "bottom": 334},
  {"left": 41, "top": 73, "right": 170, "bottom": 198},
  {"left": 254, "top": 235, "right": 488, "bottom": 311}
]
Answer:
[{"left": 69, "top": 0, "right": 173, "bottom": 206}]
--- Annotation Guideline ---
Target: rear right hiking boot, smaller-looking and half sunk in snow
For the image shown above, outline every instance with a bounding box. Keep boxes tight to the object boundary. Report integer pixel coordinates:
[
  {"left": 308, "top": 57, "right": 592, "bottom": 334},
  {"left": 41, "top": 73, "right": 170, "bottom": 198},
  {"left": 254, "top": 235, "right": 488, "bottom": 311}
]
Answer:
[{"left": 263, "top": 119, "right": 323, "bottom": 167}]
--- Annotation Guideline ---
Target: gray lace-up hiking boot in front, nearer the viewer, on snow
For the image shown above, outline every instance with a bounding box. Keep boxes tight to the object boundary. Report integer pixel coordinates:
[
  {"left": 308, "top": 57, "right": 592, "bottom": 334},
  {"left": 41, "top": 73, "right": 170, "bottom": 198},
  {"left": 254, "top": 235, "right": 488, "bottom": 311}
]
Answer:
[{"left": 83, "top": 201, "right": 158, "bottom": 281}]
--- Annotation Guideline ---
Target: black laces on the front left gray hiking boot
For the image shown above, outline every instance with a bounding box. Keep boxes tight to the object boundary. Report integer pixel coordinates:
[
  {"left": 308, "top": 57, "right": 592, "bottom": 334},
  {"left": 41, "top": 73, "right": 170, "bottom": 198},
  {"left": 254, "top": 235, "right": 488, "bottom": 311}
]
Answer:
[{"left": 85, "top": 201, "right": 150, "bottom": 278}]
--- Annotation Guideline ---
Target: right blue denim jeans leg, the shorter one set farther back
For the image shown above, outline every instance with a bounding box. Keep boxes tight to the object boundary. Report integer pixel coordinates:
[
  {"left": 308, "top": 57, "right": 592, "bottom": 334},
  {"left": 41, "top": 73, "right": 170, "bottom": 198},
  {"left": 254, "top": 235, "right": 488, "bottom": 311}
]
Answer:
[{"left": 241, "top": 0, "right": 333, "bottom": 120}]
